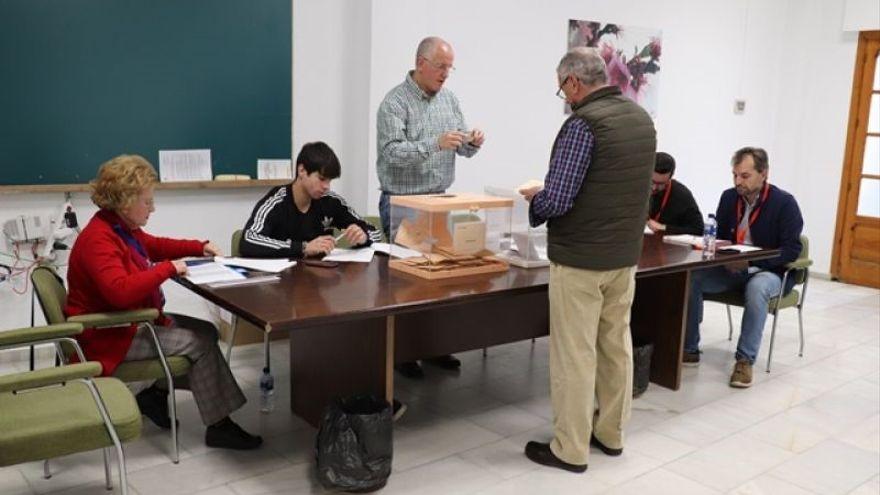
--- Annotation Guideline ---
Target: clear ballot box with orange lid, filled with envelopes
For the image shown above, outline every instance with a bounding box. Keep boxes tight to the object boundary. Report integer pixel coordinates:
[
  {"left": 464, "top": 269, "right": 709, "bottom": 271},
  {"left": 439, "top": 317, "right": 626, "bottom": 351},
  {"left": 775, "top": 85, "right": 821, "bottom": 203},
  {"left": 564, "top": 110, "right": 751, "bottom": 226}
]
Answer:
[{"left": 388, "top": 194, "right": 513, "bottom": 279}]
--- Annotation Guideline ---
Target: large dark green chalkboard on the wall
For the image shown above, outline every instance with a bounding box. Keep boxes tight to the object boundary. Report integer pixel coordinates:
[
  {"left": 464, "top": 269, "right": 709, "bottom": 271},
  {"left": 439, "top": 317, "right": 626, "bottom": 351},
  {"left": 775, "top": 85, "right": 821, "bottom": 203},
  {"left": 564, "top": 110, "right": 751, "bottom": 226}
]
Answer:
[{"left": 0, "top": 0, "right": 292, "bottom": 185}]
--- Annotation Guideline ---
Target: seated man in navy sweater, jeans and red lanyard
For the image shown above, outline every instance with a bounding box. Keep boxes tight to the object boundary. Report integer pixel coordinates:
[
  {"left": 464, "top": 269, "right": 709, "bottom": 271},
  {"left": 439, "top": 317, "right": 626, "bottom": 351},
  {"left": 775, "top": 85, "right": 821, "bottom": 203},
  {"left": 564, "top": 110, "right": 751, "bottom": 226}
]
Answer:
[{"left": 683, "top": 147, "right": 804, "bottom": 388}]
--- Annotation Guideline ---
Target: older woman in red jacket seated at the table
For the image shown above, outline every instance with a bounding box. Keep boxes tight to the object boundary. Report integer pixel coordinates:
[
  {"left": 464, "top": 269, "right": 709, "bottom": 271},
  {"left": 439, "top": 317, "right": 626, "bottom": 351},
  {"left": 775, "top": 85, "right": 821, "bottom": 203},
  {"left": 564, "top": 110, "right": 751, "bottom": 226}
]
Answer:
[{"left": 65, "top": 155, "right": 262, "bottom": 449}]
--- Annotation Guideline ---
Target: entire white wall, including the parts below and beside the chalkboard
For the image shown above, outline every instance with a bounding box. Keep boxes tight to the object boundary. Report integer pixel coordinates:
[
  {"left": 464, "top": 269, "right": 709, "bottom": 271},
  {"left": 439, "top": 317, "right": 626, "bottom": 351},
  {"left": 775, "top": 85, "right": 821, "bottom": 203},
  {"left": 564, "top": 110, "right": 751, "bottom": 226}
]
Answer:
[{"left": 0, "top": 0, "right": 868, "bottom": 328}]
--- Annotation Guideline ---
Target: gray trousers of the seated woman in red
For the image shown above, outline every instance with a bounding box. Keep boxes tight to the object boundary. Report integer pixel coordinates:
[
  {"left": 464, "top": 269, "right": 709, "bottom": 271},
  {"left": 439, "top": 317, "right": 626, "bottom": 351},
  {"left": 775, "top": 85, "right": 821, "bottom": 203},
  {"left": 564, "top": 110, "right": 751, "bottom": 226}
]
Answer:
[{"left": 125, "top": 314, "right": 247, "bottom": 425}]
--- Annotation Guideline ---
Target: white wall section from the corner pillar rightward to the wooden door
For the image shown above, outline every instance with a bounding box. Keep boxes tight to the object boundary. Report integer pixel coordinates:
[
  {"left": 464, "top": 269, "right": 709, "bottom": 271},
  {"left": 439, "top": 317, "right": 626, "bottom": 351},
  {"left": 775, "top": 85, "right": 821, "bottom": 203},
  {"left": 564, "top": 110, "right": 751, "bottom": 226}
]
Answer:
[{"left": 367, "top": 0, "right": 856, "bottom": 273}]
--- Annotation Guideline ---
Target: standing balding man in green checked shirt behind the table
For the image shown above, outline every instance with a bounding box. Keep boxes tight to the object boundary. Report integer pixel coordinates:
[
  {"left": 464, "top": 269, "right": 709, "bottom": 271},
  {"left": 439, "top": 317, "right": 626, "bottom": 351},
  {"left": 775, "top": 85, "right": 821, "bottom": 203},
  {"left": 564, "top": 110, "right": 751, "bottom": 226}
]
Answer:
[{"left": 376, "top": 37, "right": 485, "bottom": 378}]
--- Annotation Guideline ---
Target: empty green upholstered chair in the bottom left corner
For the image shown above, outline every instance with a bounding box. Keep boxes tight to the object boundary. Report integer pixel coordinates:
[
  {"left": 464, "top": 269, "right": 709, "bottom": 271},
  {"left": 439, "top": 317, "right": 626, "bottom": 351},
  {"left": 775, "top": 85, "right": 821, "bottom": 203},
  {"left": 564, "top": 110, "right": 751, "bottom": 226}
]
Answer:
[{"left": 0, "top": 323, "right": 141, "bottom": 494}]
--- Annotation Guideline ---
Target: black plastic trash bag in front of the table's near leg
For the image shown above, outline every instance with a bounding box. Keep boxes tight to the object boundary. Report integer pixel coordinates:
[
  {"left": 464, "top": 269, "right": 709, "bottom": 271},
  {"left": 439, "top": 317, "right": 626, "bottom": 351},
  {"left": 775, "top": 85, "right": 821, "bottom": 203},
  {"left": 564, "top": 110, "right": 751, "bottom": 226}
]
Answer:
[{"left": 315, "top": 395, "right": 394, "bottom": 492}]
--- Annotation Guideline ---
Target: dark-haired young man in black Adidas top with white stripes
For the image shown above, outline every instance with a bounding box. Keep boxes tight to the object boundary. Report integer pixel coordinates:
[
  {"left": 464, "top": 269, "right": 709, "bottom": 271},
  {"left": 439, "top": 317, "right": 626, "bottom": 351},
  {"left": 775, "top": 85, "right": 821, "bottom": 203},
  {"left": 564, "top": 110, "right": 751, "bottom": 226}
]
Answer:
[{"left": 239, "top": 141, "right": 381, "bottom": 258}]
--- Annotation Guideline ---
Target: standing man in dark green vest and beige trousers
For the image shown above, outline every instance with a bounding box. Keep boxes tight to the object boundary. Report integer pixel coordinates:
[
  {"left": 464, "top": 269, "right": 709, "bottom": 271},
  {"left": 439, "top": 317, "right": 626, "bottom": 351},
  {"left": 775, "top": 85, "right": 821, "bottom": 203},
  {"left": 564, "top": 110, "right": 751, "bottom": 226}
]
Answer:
[{"left": 520, "top": 47, "right": 657, "bottom": 473}]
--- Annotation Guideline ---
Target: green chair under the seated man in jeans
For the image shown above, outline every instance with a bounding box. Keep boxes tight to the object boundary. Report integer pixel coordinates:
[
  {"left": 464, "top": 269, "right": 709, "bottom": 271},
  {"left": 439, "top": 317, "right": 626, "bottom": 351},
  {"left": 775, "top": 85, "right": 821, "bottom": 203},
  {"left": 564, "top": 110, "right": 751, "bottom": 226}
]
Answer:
[{"left": 703, "top": 235, "right": 813, "bottom": 373}]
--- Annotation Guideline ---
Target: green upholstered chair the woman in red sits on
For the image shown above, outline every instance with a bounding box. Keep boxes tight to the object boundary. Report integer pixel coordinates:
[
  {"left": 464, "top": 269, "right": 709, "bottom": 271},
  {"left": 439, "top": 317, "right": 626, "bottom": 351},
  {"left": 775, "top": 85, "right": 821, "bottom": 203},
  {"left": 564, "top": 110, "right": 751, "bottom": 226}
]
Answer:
[{"left": 31, "top": 266, "right": 192, "bottom": 464}]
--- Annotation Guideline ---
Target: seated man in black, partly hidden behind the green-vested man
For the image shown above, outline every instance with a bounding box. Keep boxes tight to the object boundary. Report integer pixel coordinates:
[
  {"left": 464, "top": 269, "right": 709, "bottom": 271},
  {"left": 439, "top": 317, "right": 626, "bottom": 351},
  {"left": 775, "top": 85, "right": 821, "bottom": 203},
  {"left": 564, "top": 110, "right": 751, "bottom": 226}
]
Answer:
[{"left": 648, "top": 151, "right": 703, "bottom": 235}]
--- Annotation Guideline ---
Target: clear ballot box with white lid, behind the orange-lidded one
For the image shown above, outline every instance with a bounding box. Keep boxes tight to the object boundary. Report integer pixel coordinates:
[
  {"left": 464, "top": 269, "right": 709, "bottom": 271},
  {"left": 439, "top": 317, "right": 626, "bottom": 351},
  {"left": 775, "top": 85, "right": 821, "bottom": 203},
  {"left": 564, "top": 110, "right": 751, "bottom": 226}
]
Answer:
[{"left": 485, "top": 186, "right": 550, "bottom": 268}]
